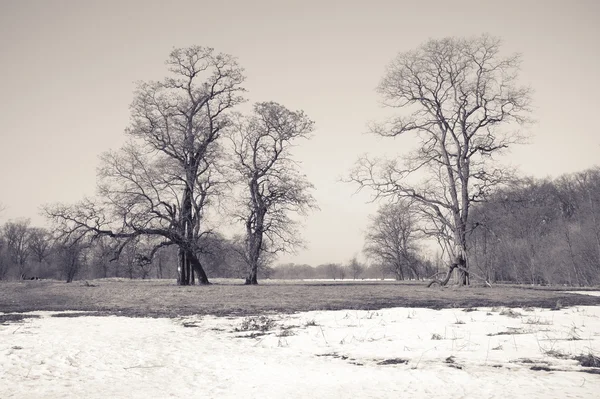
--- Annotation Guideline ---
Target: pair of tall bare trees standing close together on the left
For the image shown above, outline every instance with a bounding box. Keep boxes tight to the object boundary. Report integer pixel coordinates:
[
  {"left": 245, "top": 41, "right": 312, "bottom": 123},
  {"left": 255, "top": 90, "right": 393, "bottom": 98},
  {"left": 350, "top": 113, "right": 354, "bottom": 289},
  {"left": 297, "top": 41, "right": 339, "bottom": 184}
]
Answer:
[{"left": 45, "top": 46, "right": 315, "bottom": 285}]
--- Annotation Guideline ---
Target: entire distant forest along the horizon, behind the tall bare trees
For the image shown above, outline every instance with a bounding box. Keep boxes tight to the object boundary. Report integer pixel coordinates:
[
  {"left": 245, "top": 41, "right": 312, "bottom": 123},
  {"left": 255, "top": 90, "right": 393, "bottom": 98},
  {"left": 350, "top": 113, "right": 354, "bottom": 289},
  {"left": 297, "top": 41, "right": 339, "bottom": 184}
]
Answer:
[{"left": 0, "top": 167, "right": 600, "bottom": 286}]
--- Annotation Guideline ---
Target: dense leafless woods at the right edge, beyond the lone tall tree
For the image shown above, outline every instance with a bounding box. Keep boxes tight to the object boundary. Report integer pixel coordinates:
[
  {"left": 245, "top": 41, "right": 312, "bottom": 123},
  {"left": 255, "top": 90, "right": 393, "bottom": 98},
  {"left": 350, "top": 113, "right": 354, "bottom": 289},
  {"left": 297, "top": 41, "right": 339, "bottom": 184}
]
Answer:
[{"left": 469, "top": 167, "right": 600, "bottom": 285}]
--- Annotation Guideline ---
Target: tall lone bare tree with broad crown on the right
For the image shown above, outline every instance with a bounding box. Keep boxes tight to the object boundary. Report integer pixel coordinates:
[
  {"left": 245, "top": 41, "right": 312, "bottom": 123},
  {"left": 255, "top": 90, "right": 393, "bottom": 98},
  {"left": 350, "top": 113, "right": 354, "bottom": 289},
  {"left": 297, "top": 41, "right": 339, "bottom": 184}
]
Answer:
[{"left": 351, "top": 35, "right": 530, "bottom": 285}]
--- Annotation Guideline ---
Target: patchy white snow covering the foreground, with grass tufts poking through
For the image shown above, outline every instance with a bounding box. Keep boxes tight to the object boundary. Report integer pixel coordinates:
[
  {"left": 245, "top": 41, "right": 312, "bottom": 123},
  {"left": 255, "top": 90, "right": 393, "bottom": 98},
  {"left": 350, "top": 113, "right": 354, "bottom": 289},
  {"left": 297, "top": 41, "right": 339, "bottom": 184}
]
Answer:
[{"left": 0, "top": 306, "right": 600, "bottom": 399}]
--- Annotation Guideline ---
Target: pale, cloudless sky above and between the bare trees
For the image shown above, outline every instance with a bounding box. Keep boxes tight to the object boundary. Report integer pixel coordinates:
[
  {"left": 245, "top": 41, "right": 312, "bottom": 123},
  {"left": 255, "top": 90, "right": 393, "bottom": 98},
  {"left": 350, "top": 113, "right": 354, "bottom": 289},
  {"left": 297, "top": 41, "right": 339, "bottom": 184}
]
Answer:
[{"left": 0, "top": 0, "right": 600, "bottom": 265}]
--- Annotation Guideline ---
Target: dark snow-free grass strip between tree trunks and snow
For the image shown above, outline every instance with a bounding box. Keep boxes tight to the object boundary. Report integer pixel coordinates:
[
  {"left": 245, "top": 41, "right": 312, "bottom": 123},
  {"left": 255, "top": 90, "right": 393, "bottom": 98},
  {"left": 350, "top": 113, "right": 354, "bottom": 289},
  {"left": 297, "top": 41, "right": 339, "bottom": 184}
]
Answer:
[{"left": 0, "top": 279, "right": 600, "bottom": 317}]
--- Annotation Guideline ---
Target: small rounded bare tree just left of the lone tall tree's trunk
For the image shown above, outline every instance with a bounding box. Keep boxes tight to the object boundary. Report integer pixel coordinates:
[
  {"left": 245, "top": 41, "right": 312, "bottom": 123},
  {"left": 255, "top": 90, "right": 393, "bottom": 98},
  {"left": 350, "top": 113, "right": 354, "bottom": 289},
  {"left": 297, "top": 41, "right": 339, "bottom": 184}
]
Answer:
[{"left": 364, "top": 201, "right": 420, "bottom": 280}]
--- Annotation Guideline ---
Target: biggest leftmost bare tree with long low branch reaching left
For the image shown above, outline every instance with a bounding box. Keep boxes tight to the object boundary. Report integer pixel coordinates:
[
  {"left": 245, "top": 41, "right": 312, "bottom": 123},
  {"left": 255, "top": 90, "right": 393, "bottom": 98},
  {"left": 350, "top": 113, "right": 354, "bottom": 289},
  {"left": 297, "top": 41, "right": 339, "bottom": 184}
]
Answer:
[{"left": 46, "top": 46, "right": 244, "bottom": 285}]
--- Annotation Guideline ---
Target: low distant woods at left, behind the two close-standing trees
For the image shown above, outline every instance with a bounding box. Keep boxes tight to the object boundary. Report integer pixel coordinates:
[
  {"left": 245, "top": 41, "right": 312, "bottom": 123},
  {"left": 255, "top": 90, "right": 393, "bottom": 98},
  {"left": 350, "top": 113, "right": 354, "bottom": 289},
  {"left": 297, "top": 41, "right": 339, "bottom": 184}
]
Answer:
[{"left": 0, "top": 219, "right": 272, "bottom": 282}]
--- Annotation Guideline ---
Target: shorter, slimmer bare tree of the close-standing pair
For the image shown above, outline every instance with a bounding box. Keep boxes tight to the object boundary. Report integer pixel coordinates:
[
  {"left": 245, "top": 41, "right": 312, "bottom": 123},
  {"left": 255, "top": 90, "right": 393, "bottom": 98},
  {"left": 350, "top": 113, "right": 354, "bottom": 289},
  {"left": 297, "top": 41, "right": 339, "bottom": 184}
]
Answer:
[{"left": 231, "top": 102, "right": 316, "bottom": 284}]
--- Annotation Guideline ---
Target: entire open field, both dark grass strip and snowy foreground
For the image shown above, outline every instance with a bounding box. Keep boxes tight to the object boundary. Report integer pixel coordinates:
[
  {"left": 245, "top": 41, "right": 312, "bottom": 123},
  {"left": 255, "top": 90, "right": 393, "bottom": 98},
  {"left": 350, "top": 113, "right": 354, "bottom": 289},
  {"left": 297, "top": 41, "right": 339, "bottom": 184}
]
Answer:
[{"left": 0, "top": 279, "right": 600, "bottom": 398}]
